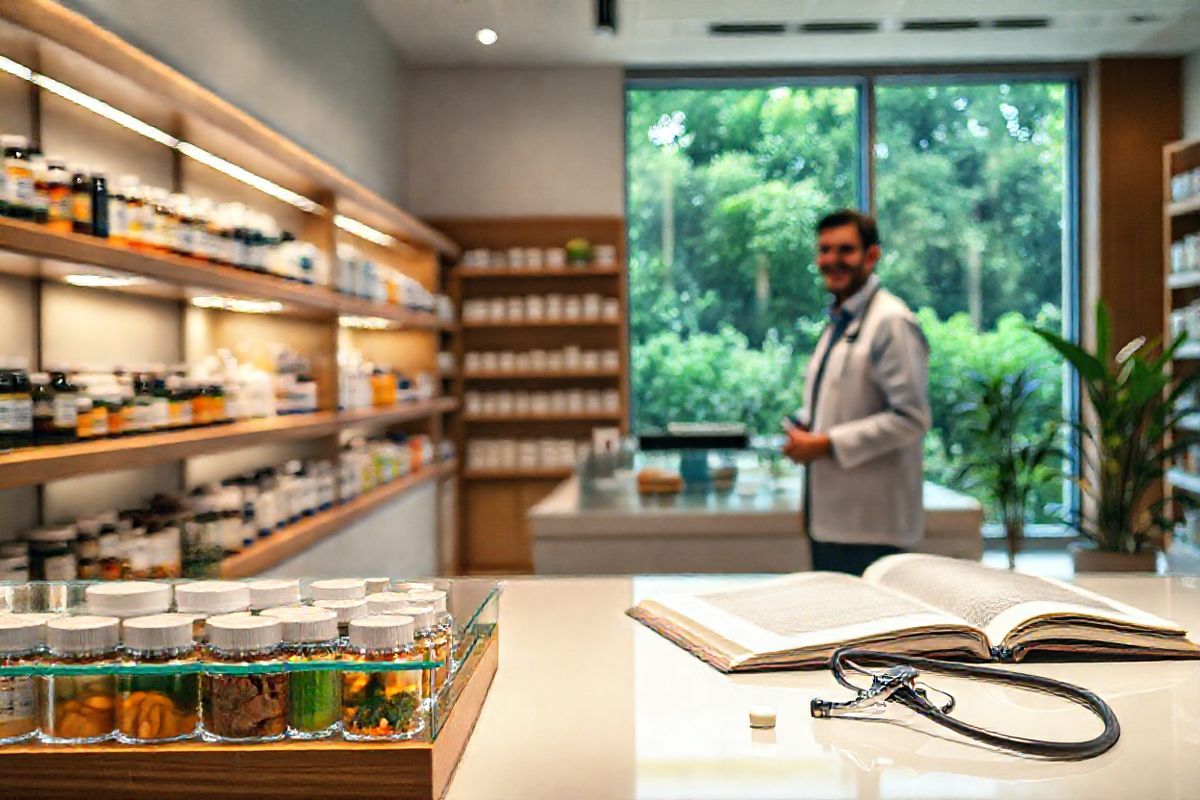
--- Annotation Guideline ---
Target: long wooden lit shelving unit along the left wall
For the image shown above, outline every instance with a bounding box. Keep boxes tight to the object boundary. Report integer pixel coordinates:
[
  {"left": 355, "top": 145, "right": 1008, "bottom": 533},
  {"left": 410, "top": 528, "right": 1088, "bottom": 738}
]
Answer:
[{"left": 0, "top": 0, "right": 460, "bottom": 575}]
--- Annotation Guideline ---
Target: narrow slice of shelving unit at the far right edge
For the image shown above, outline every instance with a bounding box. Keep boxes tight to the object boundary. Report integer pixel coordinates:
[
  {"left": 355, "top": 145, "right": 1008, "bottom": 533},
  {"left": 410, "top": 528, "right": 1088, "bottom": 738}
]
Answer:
[{"left": 1163, "top": 139, "right": 1200, "bottom": 559}]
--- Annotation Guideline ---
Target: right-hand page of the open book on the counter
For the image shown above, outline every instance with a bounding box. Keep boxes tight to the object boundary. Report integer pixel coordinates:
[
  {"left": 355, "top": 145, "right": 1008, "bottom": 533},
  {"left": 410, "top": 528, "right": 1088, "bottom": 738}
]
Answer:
[{"left": 863, "top": 553, "right": 1184, "bottom": 644}]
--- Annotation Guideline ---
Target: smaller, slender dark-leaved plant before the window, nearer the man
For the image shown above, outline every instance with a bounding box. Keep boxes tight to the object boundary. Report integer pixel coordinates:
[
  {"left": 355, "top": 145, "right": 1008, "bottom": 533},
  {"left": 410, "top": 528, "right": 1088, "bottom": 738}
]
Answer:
[{"left": 954, "top": 366, "right": 1066, "bottom": 569}]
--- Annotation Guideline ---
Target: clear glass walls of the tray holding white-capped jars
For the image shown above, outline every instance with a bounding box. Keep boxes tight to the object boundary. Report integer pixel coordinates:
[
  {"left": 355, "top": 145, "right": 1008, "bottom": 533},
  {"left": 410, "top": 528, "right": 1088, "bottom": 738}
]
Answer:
[{"left": 0, "top": 578, "right": 503, "bottom": 743}]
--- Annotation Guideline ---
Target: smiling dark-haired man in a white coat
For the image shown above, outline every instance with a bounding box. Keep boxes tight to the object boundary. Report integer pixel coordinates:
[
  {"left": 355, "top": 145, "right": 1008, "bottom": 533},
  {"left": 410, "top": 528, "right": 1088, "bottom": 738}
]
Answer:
[{"left": 784, "top": 210, "right": 930, "bottom": 575}]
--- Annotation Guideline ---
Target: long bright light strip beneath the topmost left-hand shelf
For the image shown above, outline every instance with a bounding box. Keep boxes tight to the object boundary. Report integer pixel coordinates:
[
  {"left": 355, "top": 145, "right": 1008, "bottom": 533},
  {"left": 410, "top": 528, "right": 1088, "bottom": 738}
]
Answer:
[{"left": 0, "top": 55, "right": 396, "bottom": 227}]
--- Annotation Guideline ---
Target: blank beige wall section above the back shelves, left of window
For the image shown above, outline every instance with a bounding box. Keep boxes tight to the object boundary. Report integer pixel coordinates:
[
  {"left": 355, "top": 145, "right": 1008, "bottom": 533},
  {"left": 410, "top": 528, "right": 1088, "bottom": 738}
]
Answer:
[{"left": 404, "top": 67, "right": 625, "bottom": 217}]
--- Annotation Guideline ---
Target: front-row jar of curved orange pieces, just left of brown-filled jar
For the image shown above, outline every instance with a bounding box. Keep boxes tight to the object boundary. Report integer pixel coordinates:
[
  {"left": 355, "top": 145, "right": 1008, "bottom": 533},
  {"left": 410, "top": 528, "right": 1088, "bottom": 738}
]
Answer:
[{"left": 116, "top": 614, "right": 200, "bottom": 744}]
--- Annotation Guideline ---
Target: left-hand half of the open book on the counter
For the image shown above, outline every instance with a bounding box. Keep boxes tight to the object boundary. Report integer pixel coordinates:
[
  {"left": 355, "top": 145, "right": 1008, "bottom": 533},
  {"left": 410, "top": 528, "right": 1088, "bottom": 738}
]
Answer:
[{"left": 630, "top": 572, "right": 988, "bottom": 670}]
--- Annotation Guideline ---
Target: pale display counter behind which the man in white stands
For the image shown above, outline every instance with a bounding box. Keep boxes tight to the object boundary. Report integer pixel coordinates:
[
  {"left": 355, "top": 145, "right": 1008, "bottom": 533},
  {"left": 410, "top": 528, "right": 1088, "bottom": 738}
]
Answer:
[{"left": 528, "top": 468, "right": 983, "bottom": 575}]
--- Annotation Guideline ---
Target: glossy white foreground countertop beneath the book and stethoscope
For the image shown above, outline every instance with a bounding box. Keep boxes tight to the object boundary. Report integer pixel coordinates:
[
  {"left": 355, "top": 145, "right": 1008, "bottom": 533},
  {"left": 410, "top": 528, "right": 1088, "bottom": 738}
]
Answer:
[{"left": 446, "top": 576, "right": 1200, "bottom": 800}]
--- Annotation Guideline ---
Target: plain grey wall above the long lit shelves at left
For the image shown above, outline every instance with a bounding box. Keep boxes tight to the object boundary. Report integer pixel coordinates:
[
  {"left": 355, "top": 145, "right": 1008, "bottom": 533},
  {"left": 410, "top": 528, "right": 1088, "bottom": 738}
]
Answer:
[{"left": 66, "top": 0, "right": 404, "bottom": 203}]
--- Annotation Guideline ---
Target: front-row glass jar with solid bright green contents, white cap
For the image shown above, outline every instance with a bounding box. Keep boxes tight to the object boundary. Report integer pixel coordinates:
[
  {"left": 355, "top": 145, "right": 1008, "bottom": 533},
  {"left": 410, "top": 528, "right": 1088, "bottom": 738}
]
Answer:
[{"left": 272, "top": 607, "right": 342, "bottom": 739}]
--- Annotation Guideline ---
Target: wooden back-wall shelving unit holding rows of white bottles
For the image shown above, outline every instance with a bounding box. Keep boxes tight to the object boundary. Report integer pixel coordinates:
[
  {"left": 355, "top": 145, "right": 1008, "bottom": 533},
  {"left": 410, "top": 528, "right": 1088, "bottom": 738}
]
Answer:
[{"left": 432, "top": 217, "right": 629, "bottom": 572}]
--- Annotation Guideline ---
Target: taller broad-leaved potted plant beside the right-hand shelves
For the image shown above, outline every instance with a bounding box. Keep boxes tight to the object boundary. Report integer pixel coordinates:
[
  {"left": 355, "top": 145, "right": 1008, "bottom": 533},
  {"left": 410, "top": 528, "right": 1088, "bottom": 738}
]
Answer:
[{"left": 1034, "top": 303, "right": 1200, "bottom": 572}]
